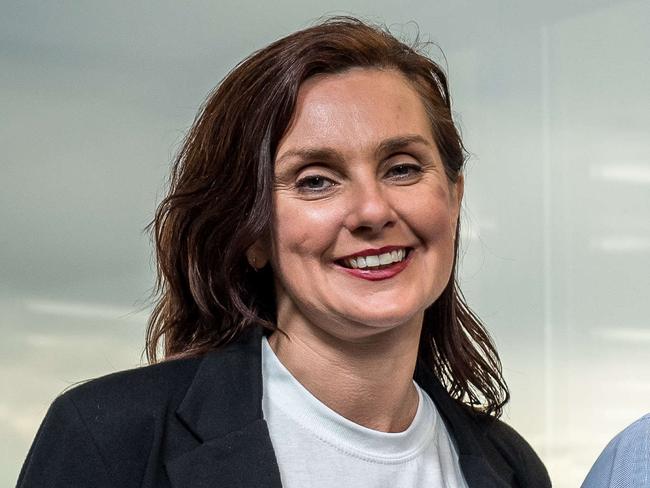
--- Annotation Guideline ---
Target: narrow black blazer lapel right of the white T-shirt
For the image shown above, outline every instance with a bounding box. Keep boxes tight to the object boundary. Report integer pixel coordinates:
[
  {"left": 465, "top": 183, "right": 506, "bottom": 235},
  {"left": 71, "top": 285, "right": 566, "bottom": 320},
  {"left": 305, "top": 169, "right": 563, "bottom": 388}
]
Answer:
[{"left": 414, "top": 362, "right": 513, "bottom": 488}]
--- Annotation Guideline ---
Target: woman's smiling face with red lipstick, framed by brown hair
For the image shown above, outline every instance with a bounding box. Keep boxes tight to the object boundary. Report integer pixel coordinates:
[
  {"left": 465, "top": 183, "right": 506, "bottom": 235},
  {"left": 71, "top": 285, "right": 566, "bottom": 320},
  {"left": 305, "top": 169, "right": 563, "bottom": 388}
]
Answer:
[{"left": 264, "top": 69, "right": 462, "bottom": 339}]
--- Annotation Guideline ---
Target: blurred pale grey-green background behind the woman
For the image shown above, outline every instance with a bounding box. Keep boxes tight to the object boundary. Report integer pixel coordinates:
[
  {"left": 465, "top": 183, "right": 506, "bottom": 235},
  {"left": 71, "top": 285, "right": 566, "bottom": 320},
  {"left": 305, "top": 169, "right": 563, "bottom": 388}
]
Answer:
[{"left": 0, "top": 0, "right": 650, "bottom": 488}]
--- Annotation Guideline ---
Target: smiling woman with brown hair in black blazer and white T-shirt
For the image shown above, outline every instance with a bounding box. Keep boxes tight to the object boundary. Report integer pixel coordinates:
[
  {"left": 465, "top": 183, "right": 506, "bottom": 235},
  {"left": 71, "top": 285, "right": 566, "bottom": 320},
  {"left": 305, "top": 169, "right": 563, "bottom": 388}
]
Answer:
[{"left": 18, "top": 18, "right": 550, "bottom": 488}]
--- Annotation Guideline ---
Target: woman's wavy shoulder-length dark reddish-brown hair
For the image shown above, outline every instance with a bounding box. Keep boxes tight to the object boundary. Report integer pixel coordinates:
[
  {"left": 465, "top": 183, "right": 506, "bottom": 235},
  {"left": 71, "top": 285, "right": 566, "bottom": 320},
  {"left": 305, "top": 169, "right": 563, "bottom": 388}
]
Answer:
[{"left": 146, "top": 17, "right": 509, "bottom": 416}]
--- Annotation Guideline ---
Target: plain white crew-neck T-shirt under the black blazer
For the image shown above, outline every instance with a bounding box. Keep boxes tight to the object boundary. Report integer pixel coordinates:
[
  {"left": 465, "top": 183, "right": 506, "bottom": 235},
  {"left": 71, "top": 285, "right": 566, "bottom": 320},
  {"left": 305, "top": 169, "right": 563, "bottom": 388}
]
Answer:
[{"left": 262, "top": 337, "right": 467, "bottom": 488}]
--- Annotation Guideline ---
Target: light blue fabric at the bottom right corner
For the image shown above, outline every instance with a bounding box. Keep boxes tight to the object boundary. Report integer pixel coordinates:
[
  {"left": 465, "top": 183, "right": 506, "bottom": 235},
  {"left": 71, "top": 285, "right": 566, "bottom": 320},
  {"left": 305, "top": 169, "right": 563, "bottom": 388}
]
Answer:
[{"left": 582, "top": 414, "right": 650, "bottom": 488}]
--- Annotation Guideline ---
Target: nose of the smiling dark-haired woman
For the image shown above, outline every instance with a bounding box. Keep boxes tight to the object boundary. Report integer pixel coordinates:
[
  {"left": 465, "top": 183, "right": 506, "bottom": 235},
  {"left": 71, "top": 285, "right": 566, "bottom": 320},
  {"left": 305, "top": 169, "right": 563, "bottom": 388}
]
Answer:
[{"left": 346, "top": 181, "right": 396, "bottom": 233}]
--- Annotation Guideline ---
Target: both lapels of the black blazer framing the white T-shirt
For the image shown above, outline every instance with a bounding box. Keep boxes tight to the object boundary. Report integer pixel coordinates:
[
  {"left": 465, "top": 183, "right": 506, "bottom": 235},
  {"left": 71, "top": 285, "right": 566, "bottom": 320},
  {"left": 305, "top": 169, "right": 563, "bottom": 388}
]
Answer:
[{"left": 167, "top": 327, "right": 513, "bottom": 488}]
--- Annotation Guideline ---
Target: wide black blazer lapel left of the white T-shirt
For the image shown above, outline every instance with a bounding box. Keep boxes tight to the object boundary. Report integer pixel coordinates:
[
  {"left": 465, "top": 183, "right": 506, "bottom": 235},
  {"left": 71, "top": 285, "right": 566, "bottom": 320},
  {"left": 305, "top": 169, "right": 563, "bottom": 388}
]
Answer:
[{"left": 166, "top": 327, "right": 282, "bottom": 488}]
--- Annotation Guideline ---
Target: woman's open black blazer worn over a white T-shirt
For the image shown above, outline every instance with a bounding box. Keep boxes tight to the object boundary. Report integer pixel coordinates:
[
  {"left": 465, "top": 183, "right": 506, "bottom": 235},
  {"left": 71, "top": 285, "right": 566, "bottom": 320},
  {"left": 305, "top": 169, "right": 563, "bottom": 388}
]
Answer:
[{"left": 17, "top": 329, "right": 551, "bottom": 488}]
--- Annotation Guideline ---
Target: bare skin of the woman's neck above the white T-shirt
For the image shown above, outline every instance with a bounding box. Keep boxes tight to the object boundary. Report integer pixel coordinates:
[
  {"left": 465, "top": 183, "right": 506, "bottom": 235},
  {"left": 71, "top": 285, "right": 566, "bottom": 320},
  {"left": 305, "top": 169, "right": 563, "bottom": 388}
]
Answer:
[{"left": 269, "top": 303, "right": 424, "bottom": 432}]
